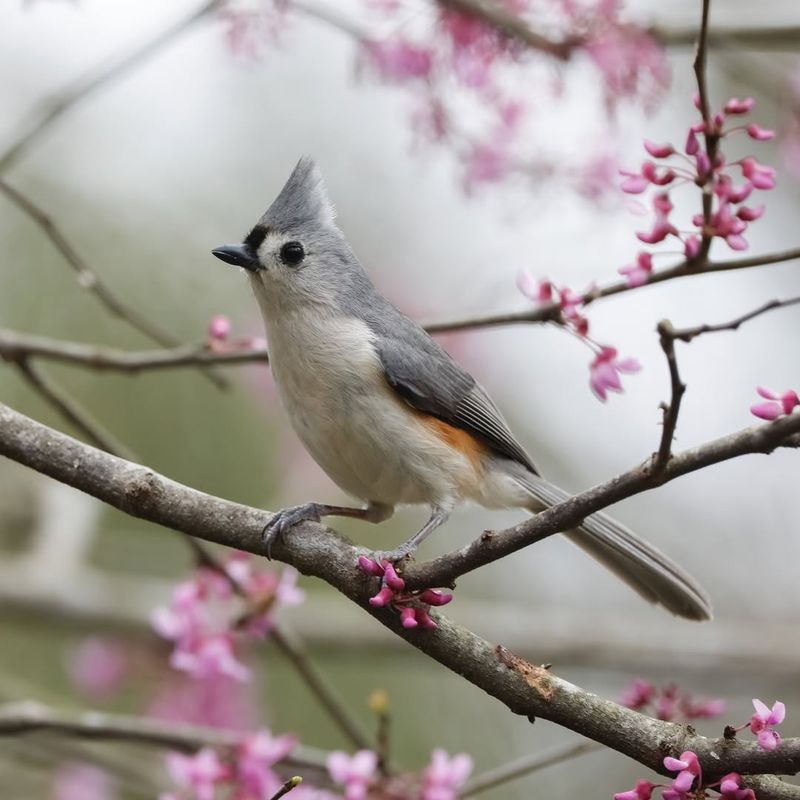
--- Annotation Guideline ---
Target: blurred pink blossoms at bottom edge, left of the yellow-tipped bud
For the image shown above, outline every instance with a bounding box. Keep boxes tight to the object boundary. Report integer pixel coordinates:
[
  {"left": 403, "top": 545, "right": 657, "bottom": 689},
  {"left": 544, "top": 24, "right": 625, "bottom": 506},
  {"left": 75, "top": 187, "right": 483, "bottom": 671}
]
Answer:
[{"left": 160, "top": 730, "right": 298, "bottom": 800}]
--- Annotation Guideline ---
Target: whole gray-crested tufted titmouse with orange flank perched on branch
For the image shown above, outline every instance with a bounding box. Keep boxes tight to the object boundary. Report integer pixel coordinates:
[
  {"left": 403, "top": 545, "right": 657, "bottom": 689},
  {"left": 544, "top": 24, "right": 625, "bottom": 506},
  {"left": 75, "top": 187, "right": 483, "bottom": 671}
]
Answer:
[{"left": 213, "top": 158, "right": 711, "bottom": 619}]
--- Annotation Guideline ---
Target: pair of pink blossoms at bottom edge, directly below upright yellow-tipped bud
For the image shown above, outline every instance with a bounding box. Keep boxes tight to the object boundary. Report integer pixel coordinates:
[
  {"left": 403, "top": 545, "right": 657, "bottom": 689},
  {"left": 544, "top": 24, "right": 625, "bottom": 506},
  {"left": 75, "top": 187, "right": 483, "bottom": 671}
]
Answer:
[{"left": 328, "top": 749, "right": 472, "bottom": 800}]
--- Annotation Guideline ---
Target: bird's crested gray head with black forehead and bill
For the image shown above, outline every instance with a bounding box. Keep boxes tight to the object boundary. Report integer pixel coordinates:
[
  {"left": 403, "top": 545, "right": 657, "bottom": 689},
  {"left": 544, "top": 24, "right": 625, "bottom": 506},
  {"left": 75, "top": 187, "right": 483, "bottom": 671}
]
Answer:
[{"left": 212, "top": 157, "right": 370, "bottom": 313}]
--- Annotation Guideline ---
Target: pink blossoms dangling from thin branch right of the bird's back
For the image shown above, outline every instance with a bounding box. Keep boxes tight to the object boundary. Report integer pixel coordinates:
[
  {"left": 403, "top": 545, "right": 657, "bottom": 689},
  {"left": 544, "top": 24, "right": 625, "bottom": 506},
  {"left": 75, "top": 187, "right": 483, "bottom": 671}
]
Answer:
[{"left": 517, "top": 270, "right": 641, "bottom": 402}]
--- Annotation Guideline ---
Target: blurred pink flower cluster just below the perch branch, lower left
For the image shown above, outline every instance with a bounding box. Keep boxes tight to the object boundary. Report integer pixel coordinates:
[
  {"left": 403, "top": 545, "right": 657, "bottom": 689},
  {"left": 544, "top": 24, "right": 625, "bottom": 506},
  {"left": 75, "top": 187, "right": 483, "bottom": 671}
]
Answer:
[{"left": 152, "top": 553, "right": 303, "bottom": 681}]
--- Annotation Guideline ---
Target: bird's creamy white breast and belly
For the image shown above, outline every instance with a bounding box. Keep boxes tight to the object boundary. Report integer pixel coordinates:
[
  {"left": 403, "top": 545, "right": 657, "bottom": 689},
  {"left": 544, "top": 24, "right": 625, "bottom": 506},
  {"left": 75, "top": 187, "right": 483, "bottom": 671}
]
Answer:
[{"left": 252, "top": 300, "right": 475, "bottom": 505}]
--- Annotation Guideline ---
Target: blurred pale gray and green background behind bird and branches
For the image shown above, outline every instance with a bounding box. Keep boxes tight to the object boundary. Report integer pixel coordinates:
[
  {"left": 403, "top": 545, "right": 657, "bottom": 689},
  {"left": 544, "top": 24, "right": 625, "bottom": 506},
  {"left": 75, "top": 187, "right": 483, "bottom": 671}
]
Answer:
[{"left": 0, "top": 0, "right": 800, "bottom": 800}]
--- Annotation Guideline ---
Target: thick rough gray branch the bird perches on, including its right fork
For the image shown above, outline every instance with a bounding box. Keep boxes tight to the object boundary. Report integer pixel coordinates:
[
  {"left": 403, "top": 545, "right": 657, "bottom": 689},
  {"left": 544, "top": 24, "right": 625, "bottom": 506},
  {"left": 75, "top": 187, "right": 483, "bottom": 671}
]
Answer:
[{"left": 0, "top": 405, "right": 800, "bottom": 800}]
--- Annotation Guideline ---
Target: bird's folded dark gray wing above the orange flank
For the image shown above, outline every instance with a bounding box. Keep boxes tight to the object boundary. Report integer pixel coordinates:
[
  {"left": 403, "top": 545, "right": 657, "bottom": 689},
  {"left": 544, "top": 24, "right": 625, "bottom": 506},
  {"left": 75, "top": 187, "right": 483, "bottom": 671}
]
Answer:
[{"left": 375, "top": 326, "right": 538, "bottom": 474}]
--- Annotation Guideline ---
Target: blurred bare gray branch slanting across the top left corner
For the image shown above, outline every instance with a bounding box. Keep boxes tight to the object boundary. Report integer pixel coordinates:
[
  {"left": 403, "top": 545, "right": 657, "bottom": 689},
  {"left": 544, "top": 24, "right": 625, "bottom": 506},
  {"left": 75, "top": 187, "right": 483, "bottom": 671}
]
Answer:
[{"left": 0, "top": 0, "right": 219, "bottom": 174}]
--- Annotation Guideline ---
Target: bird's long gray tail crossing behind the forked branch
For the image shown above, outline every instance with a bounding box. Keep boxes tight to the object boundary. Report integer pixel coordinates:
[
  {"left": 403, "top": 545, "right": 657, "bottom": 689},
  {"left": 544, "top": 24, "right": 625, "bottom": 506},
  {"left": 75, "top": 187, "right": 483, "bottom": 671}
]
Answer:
[{"left": 515, "top": 473, "right": 711, "bottom": 620}]
